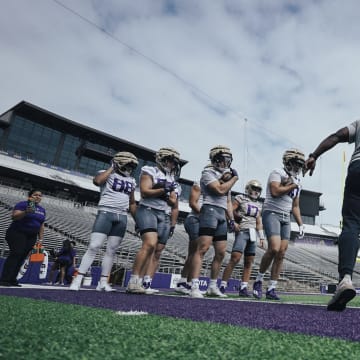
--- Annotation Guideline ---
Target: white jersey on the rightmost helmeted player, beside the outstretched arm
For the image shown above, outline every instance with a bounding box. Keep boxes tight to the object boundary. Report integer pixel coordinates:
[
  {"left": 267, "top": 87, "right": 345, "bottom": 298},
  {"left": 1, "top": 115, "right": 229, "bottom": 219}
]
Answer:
[{"left": 263, "top": 169, "right": 301, "bottom": 213}]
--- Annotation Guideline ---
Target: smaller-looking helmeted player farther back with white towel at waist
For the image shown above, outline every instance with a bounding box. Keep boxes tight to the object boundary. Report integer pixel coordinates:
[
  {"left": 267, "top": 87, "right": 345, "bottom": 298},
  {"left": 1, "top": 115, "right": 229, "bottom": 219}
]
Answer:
[{"left": 220, "top": 180, "right": 265, "bottom": 297}]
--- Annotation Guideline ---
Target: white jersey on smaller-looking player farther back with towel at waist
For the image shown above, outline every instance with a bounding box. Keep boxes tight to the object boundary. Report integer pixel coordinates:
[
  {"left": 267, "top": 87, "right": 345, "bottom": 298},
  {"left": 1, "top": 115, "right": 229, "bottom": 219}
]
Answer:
[{"left": 235, "top": 194, "right": 262, "bottom": 229}]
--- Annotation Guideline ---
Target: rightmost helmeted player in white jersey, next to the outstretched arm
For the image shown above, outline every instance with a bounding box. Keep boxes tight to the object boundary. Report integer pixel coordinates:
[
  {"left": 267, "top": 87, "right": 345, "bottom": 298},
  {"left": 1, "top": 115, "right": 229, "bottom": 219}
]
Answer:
[{"left": 253, "top": 149, "right": 305, "bottom": 300}]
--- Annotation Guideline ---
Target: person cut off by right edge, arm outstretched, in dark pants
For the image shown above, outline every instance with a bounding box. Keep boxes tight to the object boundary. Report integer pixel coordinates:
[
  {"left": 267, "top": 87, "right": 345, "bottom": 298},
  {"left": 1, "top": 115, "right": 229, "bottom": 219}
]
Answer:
[{"left": 304, "top": 120, "right": 360, "bottom": 311}]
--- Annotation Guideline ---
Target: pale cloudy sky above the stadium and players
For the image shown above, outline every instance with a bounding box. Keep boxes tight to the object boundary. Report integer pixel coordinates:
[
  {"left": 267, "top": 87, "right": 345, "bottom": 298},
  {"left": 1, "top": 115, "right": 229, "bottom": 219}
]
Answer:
[{"left": 0, "top": 0, "right": 360, "bottom": 225}]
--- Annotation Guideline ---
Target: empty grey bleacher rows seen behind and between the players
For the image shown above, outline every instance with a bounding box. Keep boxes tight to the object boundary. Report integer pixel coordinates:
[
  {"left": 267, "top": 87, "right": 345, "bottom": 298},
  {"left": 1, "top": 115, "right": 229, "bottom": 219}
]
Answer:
[{"left": 0, "top": 185, "right": 360, "bottom": 291}]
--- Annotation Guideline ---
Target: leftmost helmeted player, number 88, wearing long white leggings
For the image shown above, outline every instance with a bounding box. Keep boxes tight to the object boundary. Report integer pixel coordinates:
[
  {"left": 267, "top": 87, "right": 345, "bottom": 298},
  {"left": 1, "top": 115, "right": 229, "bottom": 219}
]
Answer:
[{"left": 70, "top": 151, "right": 139, "bottom": 292}]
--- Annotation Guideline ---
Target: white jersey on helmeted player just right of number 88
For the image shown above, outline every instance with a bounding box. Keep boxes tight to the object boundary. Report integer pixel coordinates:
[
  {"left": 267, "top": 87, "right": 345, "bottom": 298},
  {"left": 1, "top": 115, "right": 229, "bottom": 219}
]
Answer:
[{"left": 139, "top": 165, "right": 181, "bottom": 214}]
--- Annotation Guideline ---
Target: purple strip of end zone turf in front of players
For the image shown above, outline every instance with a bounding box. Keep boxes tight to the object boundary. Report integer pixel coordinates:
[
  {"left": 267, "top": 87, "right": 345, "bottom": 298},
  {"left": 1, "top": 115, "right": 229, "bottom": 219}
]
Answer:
[{"left": 0, "top": 288, "right": 360, "bottom": 341}]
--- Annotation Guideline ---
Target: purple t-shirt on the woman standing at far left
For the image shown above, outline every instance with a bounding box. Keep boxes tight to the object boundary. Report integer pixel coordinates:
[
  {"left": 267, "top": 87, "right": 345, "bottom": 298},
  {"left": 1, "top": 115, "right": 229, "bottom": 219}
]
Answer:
[{"left": 9, "top": 201, "right": 46, "bottom": 234}]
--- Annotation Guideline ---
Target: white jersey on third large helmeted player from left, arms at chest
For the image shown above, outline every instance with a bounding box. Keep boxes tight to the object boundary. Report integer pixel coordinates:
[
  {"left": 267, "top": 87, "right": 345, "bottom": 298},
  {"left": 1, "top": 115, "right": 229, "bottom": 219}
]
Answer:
[{"left": 200, "top": 167, "right": 231, "bottom": 209}]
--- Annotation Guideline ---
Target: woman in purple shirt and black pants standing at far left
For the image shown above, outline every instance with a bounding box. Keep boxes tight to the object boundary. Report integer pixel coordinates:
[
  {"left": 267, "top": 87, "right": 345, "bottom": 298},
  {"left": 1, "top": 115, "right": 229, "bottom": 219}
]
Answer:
[{"left": 0, "top": 189, "right": 46, "bottom": 286}]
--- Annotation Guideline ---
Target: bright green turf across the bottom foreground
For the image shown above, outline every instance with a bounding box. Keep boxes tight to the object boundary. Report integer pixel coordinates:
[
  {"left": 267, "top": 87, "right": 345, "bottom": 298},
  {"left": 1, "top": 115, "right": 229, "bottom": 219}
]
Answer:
[{"left": 0, "top": 296, "right": 360, "bottom": 360}]
